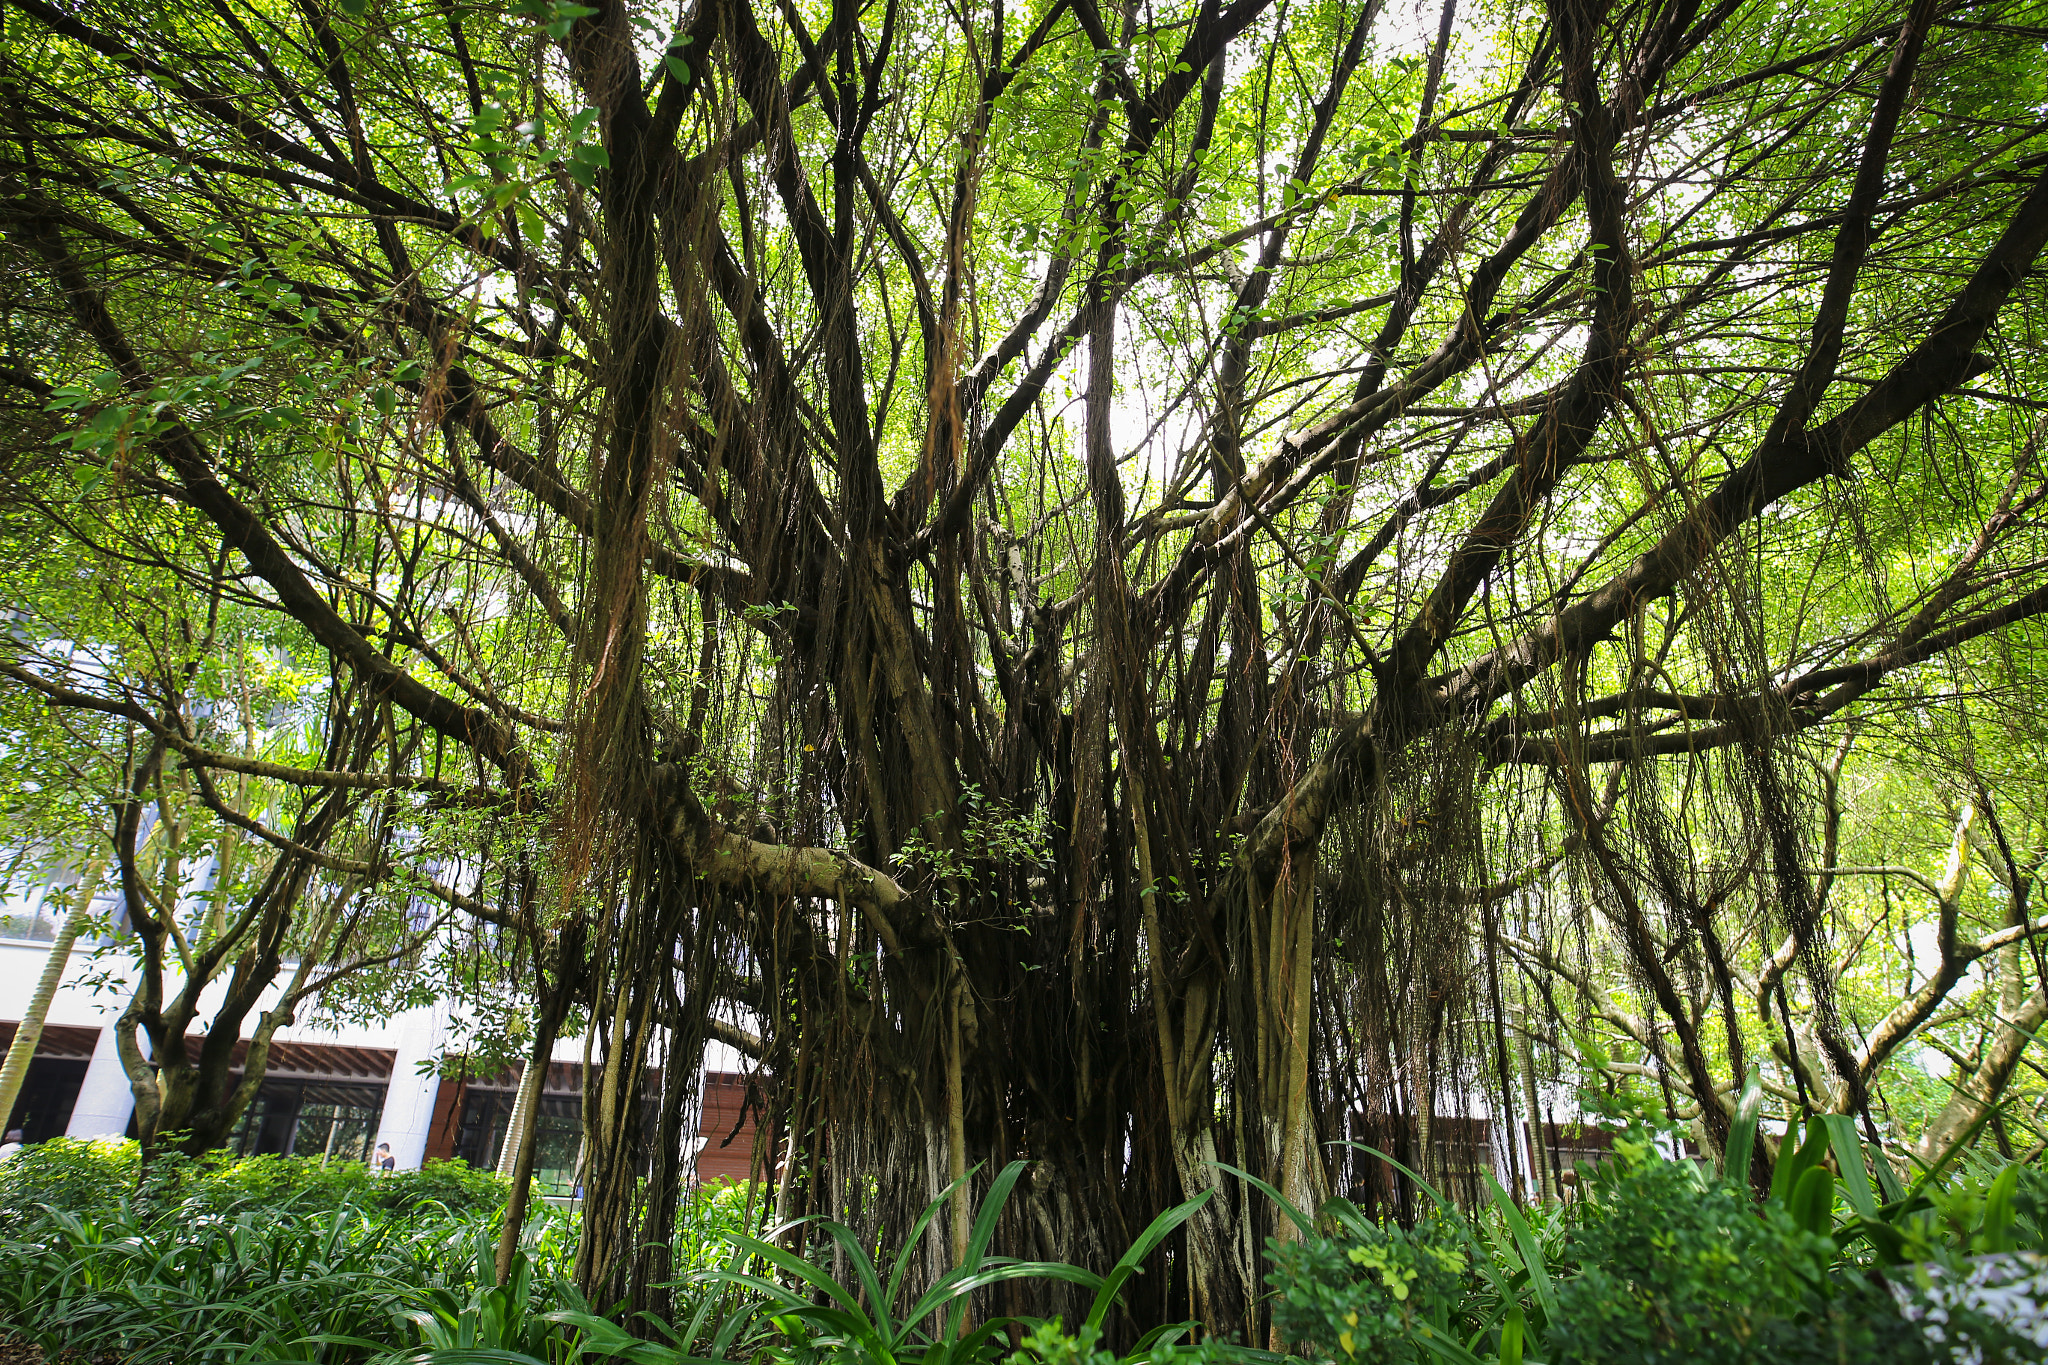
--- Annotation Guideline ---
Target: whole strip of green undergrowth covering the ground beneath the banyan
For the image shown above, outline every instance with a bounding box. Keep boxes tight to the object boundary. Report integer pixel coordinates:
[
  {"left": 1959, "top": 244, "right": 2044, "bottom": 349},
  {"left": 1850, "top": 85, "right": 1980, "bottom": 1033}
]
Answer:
[{"left": 0, "top": 1124, "right": 2048, "bottom": 1365}]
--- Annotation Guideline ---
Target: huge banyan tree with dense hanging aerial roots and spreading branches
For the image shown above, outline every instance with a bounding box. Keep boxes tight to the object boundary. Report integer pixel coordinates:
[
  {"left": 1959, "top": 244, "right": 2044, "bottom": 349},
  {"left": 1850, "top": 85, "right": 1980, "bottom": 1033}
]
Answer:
[{"left": 0, "top": 0, "right": 2048, "bottom": 1332}]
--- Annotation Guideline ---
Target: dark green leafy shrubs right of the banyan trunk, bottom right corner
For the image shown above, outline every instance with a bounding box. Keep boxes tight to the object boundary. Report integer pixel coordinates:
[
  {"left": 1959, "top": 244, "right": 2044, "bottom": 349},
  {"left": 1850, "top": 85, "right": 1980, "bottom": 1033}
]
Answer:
[{"left": 1268, "top": 1105, "right": 2048, "bottom": 1365}]
